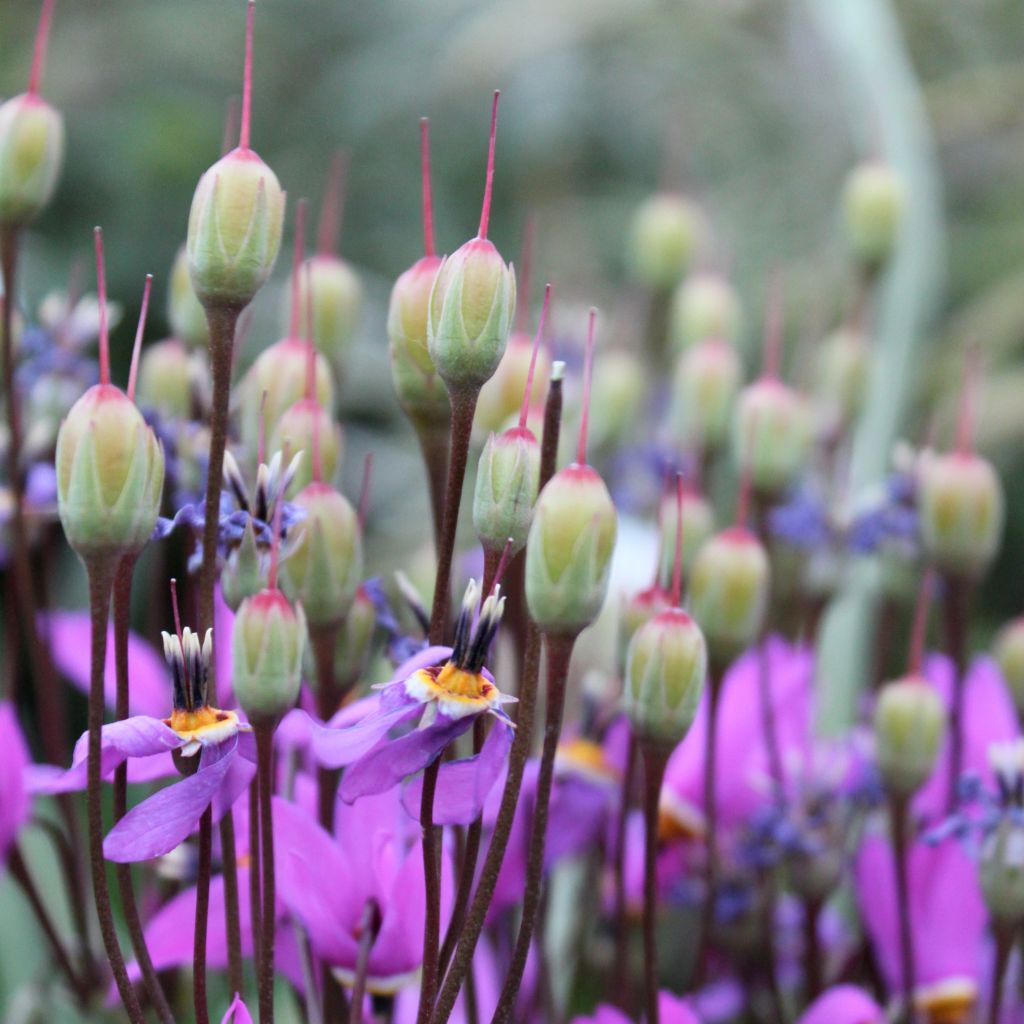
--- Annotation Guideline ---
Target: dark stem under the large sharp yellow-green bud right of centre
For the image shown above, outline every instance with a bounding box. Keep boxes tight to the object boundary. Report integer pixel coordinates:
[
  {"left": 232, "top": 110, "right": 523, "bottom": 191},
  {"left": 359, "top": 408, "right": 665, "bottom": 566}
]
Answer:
[{"left": 493, "top": 635, "right": 575, "bottom": 1024}]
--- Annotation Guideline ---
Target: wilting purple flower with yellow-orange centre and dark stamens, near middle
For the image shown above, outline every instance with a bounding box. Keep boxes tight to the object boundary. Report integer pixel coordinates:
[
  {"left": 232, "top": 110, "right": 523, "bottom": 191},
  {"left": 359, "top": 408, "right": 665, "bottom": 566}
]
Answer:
[{"left": 313, "top": 583, "right": 515, "bottom": 824}]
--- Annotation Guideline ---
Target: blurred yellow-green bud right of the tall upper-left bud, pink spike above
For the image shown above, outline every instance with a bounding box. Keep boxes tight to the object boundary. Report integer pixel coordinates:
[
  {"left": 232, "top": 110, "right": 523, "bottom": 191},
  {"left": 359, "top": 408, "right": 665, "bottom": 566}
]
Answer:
[{"left": 298, "top": 254, "right": 362, "bottom": 377}]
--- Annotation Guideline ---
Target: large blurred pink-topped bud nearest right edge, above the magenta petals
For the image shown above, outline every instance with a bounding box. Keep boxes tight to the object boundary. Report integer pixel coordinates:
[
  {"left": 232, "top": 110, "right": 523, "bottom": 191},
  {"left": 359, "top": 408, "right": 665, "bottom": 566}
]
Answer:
[{"left": 919, "top": 452, "right": 1005, "bottom": 580}]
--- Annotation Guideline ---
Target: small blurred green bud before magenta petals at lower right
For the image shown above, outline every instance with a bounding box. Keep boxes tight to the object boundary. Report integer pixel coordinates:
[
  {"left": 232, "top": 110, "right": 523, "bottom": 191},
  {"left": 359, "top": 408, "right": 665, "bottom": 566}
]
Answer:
[{"left": 874, "top": 676, "right": 946, "bottom": 800}]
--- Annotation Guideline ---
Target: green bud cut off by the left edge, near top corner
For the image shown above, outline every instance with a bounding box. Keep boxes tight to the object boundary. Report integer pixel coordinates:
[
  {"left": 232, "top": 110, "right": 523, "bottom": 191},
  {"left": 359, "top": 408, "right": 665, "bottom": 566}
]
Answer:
[{"left": 0, "top": 92, "right": 65, "bottom": 227}]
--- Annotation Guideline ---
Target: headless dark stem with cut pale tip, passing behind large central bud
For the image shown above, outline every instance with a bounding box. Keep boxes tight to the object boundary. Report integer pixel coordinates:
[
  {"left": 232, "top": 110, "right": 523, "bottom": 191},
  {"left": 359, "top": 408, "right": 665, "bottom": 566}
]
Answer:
[{"left": 431, "top": 378, "right": 562, "bottom": 1024}]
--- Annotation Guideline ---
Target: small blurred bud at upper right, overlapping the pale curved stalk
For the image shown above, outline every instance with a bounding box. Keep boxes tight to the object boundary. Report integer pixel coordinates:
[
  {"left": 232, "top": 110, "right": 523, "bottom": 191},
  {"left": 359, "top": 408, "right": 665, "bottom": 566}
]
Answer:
[{"left": 843, "top": 160, "right": 904, "bottom": 271}]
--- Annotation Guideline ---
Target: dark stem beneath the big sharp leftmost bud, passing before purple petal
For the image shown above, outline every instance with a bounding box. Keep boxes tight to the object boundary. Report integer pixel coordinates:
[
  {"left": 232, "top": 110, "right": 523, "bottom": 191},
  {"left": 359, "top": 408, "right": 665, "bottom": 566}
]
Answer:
[{"left": 86, "top": 558, "right": 144, "bottom": 1024}]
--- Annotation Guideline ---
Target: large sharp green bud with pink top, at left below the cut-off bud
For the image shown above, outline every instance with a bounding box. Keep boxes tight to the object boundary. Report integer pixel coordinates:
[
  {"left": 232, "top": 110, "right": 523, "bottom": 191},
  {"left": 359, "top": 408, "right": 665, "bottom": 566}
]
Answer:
[{"left": 56, "top": 384, "right": 164, "bottom": 559}]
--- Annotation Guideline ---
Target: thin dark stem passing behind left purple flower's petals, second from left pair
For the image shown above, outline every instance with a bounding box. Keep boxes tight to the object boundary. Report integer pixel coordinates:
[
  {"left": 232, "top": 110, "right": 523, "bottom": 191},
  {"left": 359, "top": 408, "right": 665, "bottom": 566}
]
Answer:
[{"left": 114, "top": 553, "right": 174, "bottom": 1024}]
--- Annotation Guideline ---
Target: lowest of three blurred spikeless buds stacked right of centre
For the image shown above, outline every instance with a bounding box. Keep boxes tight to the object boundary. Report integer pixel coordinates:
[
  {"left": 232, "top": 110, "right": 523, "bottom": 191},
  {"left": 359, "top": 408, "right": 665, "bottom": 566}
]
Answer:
[{"left": 670, "top": 339, "right": 742, "bottom": 452}]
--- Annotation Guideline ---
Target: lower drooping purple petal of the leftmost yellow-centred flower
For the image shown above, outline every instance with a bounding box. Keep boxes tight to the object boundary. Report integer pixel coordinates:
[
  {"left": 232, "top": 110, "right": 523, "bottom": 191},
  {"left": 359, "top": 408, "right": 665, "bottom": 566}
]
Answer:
[{"left": 103, "top": 740, "right": 238, "bottom": 863}]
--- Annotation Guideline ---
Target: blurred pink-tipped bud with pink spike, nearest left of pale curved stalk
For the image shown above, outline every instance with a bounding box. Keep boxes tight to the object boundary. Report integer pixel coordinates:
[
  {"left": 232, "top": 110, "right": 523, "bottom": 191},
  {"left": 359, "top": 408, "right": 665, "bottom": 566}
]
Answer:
[{"left": 732, "top": 377, "right": 812, "bottom": 497}]
